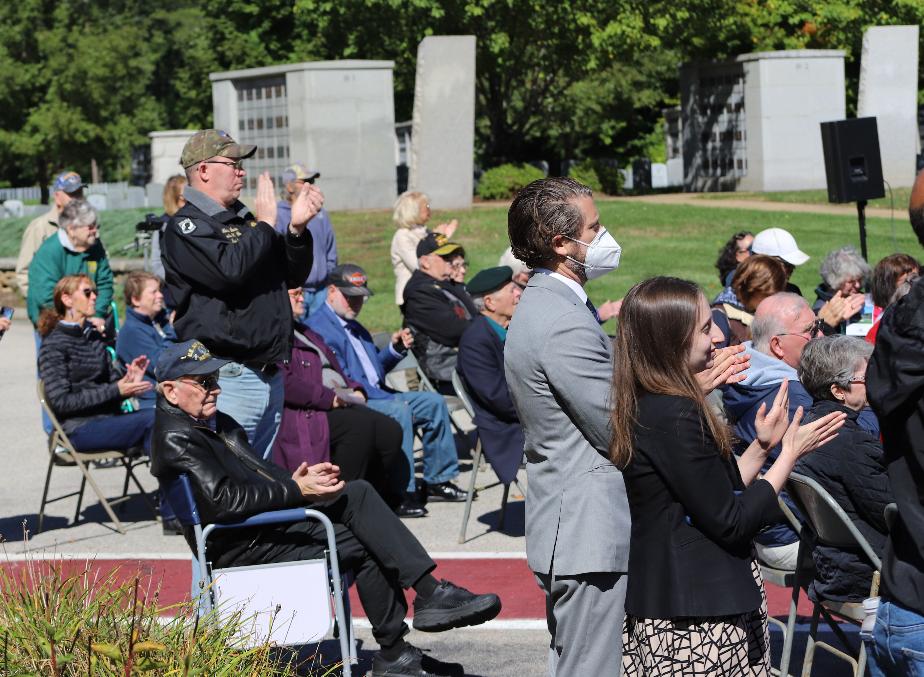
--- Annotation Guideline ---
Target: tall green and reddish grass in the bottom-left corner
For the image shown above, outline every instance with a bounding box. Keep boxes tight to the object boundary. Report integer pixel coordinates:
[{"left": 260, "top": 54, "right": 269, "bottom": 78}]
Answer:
[{"left": 0, "top": 561, "right": 336, "bottom": 677}]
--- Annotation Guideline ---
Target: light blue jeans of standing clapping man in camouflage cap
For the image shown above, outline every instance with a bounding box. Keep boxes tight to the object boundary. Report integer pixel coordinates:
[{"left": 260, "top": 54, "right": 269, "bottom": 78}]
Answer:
[{"left": 218, "top": 362, "right": 284, "bottom": 459}]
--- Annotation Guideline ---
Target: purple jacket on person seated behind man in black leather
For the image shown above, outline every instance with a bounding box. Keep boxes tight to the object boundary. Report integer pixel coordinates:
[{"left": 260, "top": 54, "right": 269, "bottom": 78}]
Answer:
[{"left": 273, "top": 325, "right": 365, "bottom": 472}]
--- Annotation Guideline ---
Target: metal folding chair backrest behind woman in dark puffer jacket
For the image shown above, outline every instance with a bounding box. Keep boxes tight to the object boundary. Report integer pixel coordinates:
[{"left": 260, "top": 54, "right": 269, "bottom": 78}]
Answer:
[{"left": 786, "top": 473, "right": 882, "bottom": 570}]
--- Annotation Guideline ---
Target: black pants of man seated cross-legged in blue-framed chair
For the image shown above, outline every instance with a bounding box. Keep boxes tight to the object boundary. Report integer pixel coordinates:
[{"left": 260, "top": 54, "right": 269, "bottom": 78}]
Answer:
[{"left": 217, "top": 480, "right": 436, "bottom": 646}]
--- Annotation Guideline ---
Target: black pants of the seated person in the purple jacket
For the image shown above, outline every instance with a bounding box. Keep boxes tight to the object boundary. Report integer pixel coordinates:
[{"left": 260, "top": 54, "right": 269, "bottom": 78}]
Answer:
[{"left": 326, "top": 406, "right": 411, "bottom": 507}]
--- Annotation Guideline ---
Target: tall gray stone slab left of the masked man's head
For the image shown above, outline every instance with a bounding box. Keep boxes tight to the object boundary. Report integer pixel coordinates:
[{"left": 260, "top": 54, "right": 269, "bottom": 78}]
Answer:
[{"left": 409, "top": 35, "right": 475, "bottom": 209}]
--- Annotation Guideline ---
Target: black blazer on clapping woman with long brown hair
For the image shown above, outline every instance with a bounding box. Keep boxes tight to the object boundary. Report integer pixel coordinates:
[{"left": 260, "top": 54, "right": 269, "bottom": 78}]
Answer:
[{"left": 623, "top": 393, "right": 779, "bottom": 618}]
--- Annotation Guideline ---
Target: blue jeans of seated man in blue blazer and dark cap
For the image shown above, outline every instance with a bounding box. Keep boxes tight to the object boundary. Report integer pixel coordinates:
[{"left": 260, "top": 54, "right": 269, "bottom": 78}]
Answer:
[{"left": 367, "top": 393, "right": 459, "bottom": 492}]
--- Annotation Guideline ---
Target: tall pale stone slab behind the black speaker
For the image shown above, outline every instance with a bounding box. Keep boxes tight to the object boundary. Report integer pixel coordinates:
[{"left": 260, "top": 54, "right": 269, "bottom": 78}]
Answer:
[{"left": 857, "top": 26, "right": 921, "bottom": 188}]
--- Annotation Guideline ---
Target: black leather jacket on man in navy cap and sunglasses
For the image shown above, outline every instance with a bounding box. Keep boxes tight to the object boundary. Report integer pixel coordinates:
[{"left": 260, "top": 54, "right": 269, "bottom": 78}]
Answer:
[{"left": 151, "top": 396, "right": 305, "bottom": 566}]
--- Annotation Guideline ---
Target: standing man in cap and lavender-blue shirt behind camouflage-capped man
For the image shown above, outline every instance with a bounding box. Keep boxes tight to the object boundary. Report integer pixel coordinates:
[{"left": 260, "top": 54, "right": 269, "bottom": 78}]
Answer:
[{"left": 276, "top": 163, "right": 337, "bottom": 322}]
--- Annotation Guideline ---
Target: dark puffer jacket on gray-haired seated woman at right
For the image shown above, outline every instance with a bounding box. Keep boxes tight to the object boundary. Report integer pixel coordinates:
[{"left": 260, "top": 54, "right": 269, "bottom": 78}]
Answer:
[{"left": 796, "top": 400, "right": 893, "bottom": 602}]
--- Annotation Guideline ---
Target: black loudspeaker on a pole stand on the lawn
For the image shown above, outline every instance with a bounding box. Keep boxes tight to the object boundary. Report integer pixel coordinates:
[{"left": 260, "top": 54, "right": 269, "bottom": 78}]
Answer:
[{"left": 821, "top": 118, "right": 885, "bottom": 259}]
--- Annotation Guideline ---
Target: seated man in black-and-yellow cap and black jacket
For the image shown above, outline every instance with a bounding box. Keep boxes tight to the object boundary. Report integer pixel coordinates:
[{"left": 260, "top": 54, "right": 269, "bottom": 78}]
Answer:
[{"left": 402, "top": 233, "right": 472, "bottom": 395}]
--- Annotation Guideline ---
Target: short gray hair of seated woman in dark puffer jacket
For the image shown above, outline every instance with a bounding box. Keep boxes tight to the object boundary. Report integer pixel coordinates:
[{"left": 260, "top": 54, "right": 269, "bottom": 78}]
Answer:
[{"left": 799, "top": 334, "right": 873, "bottom": 400}]
